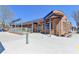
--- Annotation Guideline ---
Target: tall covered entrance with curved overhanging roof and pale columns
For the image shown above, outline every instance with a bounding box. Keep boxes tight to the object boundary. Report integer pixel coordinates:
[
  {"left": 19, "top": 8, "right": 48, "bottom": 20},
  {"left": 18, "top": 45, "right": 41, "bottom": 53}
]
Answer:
[{"left": 44, "top": 11, "right": 64, "bottom": 36}]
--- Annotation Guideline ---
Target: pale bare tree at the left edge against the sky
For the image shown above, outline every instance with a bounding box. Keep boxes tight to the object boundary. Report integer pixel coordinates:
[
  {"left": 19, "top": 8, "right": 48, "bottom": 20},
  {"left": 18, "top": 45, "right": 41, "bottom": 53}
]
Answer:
[{"left": 0, "top": 5, "right": 14, "bottom": 27}]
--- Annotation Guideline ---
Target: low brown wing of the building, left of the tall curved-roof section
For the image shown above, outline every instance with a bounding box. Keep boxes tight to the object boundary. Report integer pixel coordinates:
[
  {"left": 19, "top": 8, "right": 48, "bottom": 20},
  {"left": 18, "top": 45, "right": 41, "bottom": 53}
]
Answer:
[{"left": 23, "top": 18, "right": 44, "bottom": 32}]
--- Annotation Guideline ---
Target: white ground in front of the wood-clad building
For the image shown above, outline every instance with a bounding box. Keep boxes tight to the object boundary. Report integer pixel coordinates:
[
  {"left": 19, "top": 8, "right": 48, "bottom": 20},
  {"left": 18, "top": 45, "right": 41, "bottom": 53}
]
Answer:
[{"left": 0, "top": 32, "right": 79, "bottom": 54}]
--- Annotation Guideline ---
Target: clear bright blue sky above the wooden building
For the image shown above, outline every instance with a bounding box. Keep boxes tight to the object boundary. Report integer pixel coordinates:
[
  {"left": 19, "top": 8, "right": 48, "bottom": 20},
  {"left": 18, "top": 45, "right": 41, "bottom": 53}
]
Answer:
[{"left": 9, "top": 5, "right": 79, "bottom": 26}]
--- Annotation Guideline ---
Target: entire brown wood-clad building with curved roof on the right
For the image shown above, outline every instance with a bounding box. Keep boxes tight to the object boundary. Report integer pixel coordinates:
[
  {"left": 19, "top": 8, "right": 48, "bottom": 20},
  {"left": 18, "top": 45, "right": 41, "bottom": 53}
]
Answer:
[{"left": 23, "top": 10, "right": 72, "bottom": 36}]
